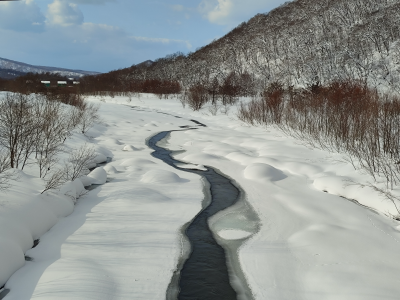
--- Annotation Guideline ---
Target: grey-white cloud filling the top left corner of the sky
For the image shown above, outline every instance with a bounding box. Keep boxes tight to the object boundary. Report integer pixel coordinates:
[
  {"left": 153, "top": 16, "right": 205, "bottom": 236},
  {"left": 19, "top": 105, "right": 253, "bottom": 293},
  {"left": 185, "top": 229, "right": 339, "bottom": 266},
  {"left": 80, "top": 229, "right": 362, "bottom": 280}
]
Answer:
[{"left": 0, "top": 0, "right": 45, "bottom": 32}]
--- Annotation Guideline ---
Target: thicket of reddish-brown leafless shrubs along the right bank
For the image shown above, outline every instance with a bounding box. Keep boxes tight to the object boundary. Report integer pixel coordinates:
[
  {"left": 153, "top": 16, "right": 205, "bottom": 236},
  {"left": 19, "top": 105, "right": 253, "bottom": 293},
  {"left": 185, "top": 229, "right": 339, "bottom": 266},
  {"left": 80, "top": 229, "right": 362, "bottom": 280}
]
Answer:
[{"left": 238, "top": 81, "right": 400, "bottom": 204}]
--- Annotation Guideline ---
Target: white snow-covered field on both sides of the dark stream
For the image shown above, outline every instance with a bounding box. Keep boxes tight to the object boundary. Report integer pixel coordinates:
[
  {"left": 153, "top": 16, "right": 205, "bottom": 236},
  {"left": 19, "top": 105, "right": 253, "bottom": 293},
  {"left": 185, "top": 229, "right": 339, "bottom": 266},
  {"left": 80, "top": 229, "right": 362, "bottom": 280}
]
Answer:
[{"left": 0, "top": 95, "right": 400, "bottom": 300}]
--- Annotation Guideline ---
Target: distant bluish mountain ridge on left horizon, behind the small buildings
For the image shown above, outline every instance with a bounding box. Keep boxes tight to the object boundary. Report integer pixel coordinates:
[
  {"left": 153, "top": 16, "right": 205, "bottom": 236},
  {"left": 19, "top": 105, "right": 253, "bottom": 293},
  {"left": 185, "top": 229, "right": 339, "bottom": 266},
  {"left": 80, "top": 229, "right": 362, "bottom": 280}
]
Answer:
[{"left": 0, "top": 57, "right": 100, "bottom": 79}]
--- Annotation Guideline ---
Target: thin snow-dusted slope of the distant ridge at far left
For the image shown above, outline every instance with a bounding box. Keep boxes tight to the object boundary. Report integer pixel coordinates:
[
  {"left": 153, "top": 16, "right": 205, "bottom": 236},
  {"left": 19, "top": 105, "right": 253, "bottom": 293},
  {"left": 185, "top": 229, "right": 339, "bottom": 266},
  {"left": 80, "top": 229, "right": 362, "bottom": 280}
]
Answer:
[{"left": 0, "top": 57, "right": 99, "bottom": 77}]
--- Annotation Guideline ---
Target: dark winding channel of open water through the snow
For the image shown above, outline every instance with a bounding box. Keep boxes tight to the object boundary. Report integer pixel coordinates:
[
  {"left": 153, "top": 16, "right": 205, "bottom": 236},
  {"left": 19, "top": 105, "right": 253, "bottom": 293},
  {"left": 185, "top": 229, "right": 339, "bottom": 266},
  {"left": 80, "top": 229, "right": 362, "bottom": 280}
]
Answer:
[{"left": 147, "top": 130, "right": 240, "bottom": 300}]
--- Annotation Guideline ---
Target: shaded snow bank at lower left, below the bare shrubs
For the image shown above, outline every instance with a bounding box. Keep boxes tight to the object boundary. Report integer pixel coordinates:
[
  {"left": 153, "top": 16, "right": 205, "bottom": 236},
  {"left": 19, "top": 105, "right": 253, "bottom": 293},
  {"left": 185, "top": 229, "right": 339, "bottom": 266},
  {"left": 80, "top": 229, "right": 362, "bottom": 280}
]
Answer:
[{"left": 0, "top": 190, "right": 74, "bottom": 286}]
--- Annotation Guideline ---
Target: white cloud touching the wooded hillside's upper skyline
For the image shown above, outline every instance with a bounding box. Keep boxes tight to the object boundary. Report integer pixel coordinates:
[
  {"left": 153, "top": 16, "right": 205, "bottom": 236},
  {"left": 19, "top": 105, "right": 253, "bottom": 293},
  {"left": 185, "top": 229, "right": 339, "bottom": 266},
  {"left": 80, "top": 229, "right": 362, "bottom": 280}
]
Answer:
[{"left": 198, "top": 0, "right": 285, "bottom": 25}]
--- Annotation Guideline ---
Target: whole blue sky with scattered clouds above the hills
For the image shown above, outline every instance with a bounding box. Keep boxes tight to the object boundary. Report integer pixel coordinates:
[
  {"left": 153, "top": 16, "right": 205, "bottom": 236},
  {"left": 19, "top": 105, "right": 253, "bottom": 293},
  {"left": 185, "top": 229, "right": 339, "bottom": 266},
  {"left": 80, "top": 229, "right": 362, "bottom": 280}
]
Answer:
[{"left": 0, "top": 0, "right": 285, "bottom": 72}]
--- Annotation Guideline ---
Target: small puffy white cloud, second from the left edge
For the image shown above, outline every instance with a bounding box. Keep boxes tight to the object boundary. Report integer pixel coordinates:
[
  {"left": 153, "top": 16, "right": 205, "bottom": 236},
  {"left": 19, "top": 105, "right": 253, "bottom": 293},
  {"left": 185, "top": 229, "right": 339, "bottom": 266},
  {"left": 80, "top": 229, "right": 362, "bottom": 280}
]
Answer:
[{"left": 47, "top": 0, "right": 83, "bottom": 26}]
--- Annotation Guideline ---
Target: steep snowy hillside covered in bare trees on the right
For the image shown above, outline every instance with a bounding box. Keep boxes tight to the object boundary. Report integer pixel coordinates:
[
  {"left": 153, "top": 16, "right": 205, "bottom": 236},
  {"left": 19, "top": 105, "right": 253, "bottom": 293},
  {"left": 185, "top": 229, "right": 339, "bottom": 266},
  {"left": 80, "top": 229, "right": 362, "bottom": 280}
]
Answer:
[{"left": 87, "top": 0, "right": 400, "bottom": 92}]
